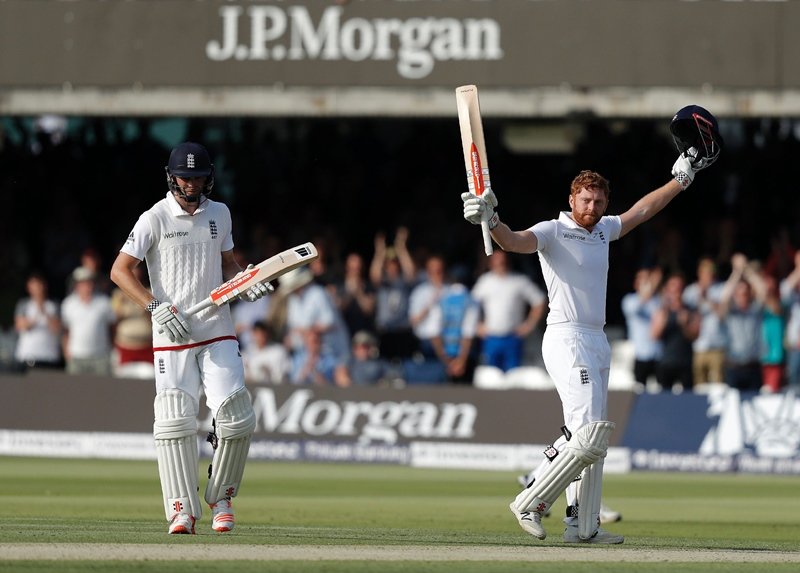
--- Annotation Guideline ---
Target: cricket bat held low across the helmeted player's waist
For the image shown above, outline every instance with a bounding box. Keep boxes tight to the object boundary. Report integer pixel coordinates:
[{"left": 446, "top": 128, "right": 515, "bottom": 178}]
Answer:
[{"left": 183, "top": 243, "right": 319, "bottom": 315}]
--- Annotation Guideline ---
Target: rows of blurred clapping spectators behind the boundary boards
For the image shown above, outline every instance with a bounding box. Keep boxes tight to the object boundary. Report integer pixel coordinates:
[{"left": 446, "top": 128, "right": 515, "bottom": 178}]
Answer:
[{"left": 10, "top": 228, "right": 800, "bottom": 392}]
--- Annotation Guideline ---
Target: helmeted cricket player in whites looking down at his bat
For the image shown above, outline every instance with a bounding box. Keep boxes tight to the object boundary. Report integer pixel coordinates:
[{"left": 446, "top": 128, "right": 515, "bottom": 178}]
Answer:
[{"left": 111, "top": 142, "right": 271, "bottom": 533}]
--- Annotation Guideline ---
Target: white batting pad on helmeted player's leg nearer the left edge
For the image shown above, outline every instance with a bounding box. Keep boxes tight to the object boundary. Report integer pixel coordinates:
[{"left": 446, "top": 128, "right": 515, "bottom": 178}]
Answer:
[{"left": 153, "top": 389, "right": 203, "bottom": 521}]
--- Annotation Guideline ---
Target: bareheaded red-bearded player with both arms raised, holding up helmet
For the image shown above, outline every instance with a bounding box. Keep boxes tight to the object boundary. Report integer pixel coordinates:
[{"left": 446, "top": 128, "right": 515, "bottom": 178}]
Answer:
[{"left": 462, "top": 106, "right": 722, "bottom": 544}]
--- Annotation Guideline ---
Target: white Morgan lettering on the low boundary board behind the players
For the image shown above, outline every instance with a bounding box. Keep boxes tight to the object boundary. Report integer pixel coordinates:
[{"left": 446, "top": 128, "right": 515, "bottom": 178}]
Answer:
[{"left": 253, "top": 388, "right": 478, "bottom": 444}]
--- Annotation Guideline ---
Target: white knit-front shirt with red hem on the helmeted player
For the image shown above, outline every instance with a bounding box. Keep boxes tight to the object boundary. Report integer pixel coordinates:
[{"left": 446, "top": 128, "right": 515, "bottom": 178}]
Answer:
[{"left": 120, "top": 192, "right": 235, "bottom": 348}]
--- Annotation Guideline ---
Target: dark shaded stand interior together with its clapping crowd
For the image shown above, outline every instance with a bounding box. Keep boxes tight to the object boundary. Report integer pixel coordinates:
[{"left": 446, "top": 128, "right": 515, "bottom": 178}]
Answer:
[{"left": 0, "top": 117, "right": 800, "bottom": 396}]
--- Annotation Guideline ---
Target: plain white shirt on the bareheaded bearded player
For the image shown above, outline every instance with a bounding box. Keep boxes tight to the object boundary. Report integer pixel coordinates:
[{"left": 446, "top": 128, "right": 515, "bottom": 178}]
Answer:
[{"left": 530, "top": 211, "right": 622, "bottom": 328}]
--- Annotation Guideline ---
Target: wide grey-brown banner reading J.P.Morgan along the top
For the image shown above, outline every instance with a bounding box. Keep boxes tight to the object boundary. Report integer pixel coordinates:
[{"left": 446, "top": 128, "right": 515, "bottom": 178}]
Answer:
[{"left": 0, "top": 0, "right": 800, "bottom": 89}]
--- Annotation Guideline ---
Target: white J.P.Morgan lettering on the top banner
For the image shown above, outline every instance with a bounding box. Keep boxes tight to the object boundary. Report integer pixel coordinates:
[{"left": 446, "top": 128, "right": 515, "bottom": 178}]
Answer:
[{"left": 206, "top": 5, "right": 503, "bottom": 79}]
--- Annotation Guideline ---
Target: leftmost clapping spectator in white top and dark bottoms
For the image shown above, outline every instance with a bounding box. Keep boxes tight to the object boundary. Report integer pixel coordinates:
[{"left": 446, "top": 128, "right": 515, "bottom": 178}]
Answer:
[{"left": 14, "top": 273, "right": 63, "bottom": 368}]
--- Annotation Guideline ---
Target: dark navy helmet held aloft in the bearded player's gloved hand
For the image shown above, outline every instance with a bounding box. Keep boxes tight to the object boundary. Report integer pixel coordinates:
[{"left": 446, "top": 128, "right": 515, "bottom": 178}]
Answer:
[{"left": 669, "top": 105, "right": 724, "bottom": 171}]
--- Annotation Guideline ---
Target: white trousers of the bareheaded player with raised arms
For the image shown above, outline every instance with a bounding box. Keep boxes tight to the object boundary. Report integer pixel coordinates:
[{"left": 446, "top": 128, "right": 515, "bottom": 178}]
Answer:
[{"left": 542, "top": 324, "right": 611, "bottom": 505}]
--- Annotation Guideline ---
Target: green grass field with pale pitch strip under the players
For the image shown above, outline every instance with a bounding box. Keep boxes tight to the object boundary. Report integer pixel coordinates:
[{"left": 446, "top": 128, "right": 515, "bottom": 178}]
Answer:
[{"left": 0, "top": 458, "right": 800, "bottom": 573}]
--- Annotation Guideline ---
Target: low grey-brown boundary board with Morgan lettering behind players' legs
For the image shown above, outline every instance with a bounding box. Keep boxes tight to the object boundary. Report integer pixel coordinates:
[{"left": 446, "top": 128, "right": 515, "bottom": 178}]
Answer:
[{"left": 0, "top": 374, "right": 634, "bottom": 471}]
